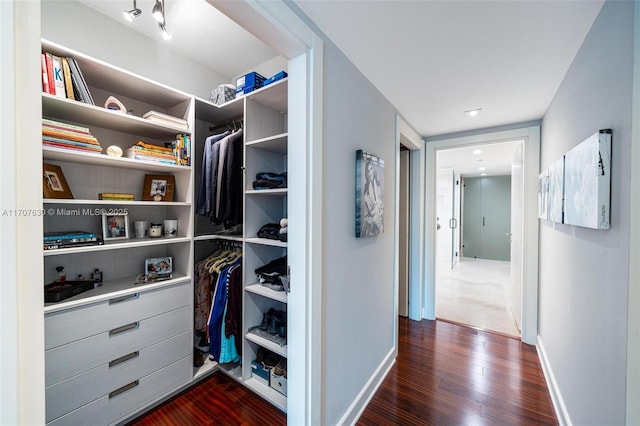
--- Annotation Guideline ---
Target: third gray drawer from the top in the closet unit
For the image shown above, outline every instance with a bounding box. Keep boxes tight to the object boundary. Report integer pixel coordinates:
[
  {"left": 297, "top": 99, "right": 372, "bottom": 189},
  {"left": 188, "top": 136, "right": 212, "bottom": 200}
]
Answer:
[{"left": 45, "top": 333, "right": 192, "bottom": 422}]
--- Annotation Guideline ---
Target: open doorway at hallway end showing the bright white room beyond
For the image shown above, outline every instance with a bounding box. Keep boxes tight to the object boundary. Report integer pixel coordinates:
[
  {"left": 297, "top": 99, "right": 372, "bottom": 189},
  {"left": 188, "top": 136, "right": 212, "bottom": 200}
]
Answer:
[{"left": 435, "top": 140, "right": 523, "bottom": 338}]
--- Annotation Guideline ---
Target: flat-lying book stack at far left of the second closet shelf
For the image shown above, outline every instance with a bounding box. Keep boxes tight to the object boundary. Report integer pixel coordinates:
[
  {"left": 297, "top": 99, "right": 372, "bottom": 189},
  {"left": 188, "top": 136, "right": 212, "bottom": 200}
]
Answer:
[{"left": 42, "top": 118, "right": 102, "bottom": 153}]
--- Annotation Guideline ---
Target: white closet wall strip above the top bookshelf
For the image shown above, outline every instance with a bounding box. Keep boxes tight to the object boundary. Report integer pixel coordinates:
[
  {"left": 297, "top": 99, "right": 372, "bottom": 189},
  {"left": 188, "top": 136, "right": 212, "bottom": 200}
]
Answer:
[{"left": 42, "top": 0, "right": 231, "bottom": 99}]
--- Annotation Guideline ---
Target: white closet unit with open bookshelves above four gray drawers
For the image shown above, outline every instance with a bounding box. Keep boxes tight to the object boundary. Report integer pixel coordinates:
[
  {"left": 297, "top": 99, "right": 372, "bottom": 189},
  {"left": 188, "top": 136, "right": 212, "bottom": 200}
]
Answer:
[{"left": 42, "top": 41, "right": 194, "bottom": 424}]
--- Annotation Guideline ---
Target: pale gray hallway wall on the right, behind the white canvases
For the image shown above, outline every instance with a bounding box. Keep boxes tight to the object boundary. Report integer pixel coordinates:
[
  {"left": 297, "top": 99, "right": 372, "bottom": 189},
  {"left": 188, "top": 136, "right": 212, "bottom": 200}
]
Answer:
[{"left": 539, "top": 1, "right": 637, "bottom": 425}]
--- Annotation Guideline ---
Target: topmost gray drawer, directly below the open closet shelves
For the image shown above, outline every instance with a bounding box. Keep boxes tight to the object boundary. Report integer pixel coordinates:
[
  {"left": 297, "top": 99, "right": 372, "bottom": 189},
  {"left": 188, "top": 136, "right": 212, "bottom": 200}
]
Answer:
[{"left": 44, "top": 282, "right": 193, "bottom": 349}]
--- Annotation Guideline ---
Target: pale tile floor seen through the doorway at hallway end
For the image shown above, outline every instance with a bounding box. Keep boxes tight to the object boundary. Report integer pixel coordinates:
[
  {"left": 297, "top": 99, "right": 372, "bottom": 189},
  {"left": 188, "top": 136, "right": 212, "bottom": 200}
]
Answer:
[{"left": 436, "top": 258, "right": 520, "bottom": 337}]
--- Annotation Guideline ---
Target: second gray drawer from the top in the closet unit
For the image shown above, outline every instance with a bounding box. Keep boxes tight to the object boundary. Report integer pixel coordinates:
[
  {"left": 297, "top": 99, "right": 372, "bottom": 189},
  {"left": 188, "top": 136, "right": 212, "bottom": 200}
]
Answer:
[{"left": 44, "top": 307, "right": 192, "bottom": 386}]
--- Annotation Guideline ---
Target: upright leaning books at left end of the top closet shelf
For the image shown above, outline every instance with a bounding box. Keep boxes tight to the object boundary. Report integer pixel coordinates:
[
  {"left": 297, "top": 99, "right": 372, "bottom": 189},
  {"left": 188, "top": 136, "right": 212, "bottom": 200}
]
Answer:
[{"left": 41, "top": 52, "right": 95, "bottom": 105}]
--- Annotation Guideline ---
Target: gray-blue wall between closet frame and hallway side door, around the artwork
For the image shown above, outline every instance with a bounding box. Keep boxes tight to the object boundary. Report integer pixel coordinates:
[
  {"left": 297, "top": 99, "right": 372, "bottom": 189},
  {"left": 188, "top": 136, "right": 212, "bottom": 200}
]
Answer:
[{"left": 323, "top": 42, "right": 396, "bottom": 424}]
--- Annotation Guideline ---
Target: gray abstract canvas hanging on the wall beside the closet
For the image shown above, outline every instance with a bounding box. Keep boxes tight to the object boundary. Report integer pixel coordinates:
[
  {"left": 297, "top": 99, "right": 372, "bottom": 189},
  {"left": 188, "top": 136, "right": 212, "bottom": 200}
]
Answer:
[{"left": 356, "top": 149, "right": 384, "bottom": 238}]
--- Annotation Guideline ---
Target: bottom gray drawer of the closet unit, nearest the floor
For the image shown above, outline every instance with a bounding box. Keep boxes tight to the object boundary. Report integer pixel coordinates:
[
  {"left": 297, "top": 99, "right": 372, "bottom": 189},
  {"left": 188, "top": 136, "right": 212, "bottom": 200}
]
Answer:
[{"left": 47, "top": 357, "right": 192, "bottom": 426}]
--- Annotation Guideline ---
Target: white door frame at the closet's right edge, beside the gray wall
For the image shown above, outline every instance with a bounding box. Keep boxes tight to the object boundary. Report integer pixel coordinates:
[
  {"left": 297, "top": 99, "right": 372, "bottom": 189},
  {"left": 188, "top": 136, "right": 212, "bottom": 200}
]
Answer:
[{"left": 208, "top": 0, "right": 325, "bottom": 424}]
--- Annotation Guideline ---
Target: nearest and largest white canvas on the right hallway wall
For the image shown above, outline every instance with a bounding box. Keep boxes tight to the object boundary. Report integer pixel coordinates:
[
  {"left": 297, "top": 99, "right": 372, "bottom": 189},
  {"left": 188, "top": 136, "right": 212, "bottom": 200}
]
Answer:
[{"left": 564, "top": 129, "right": 611, "bottom": 229}]
